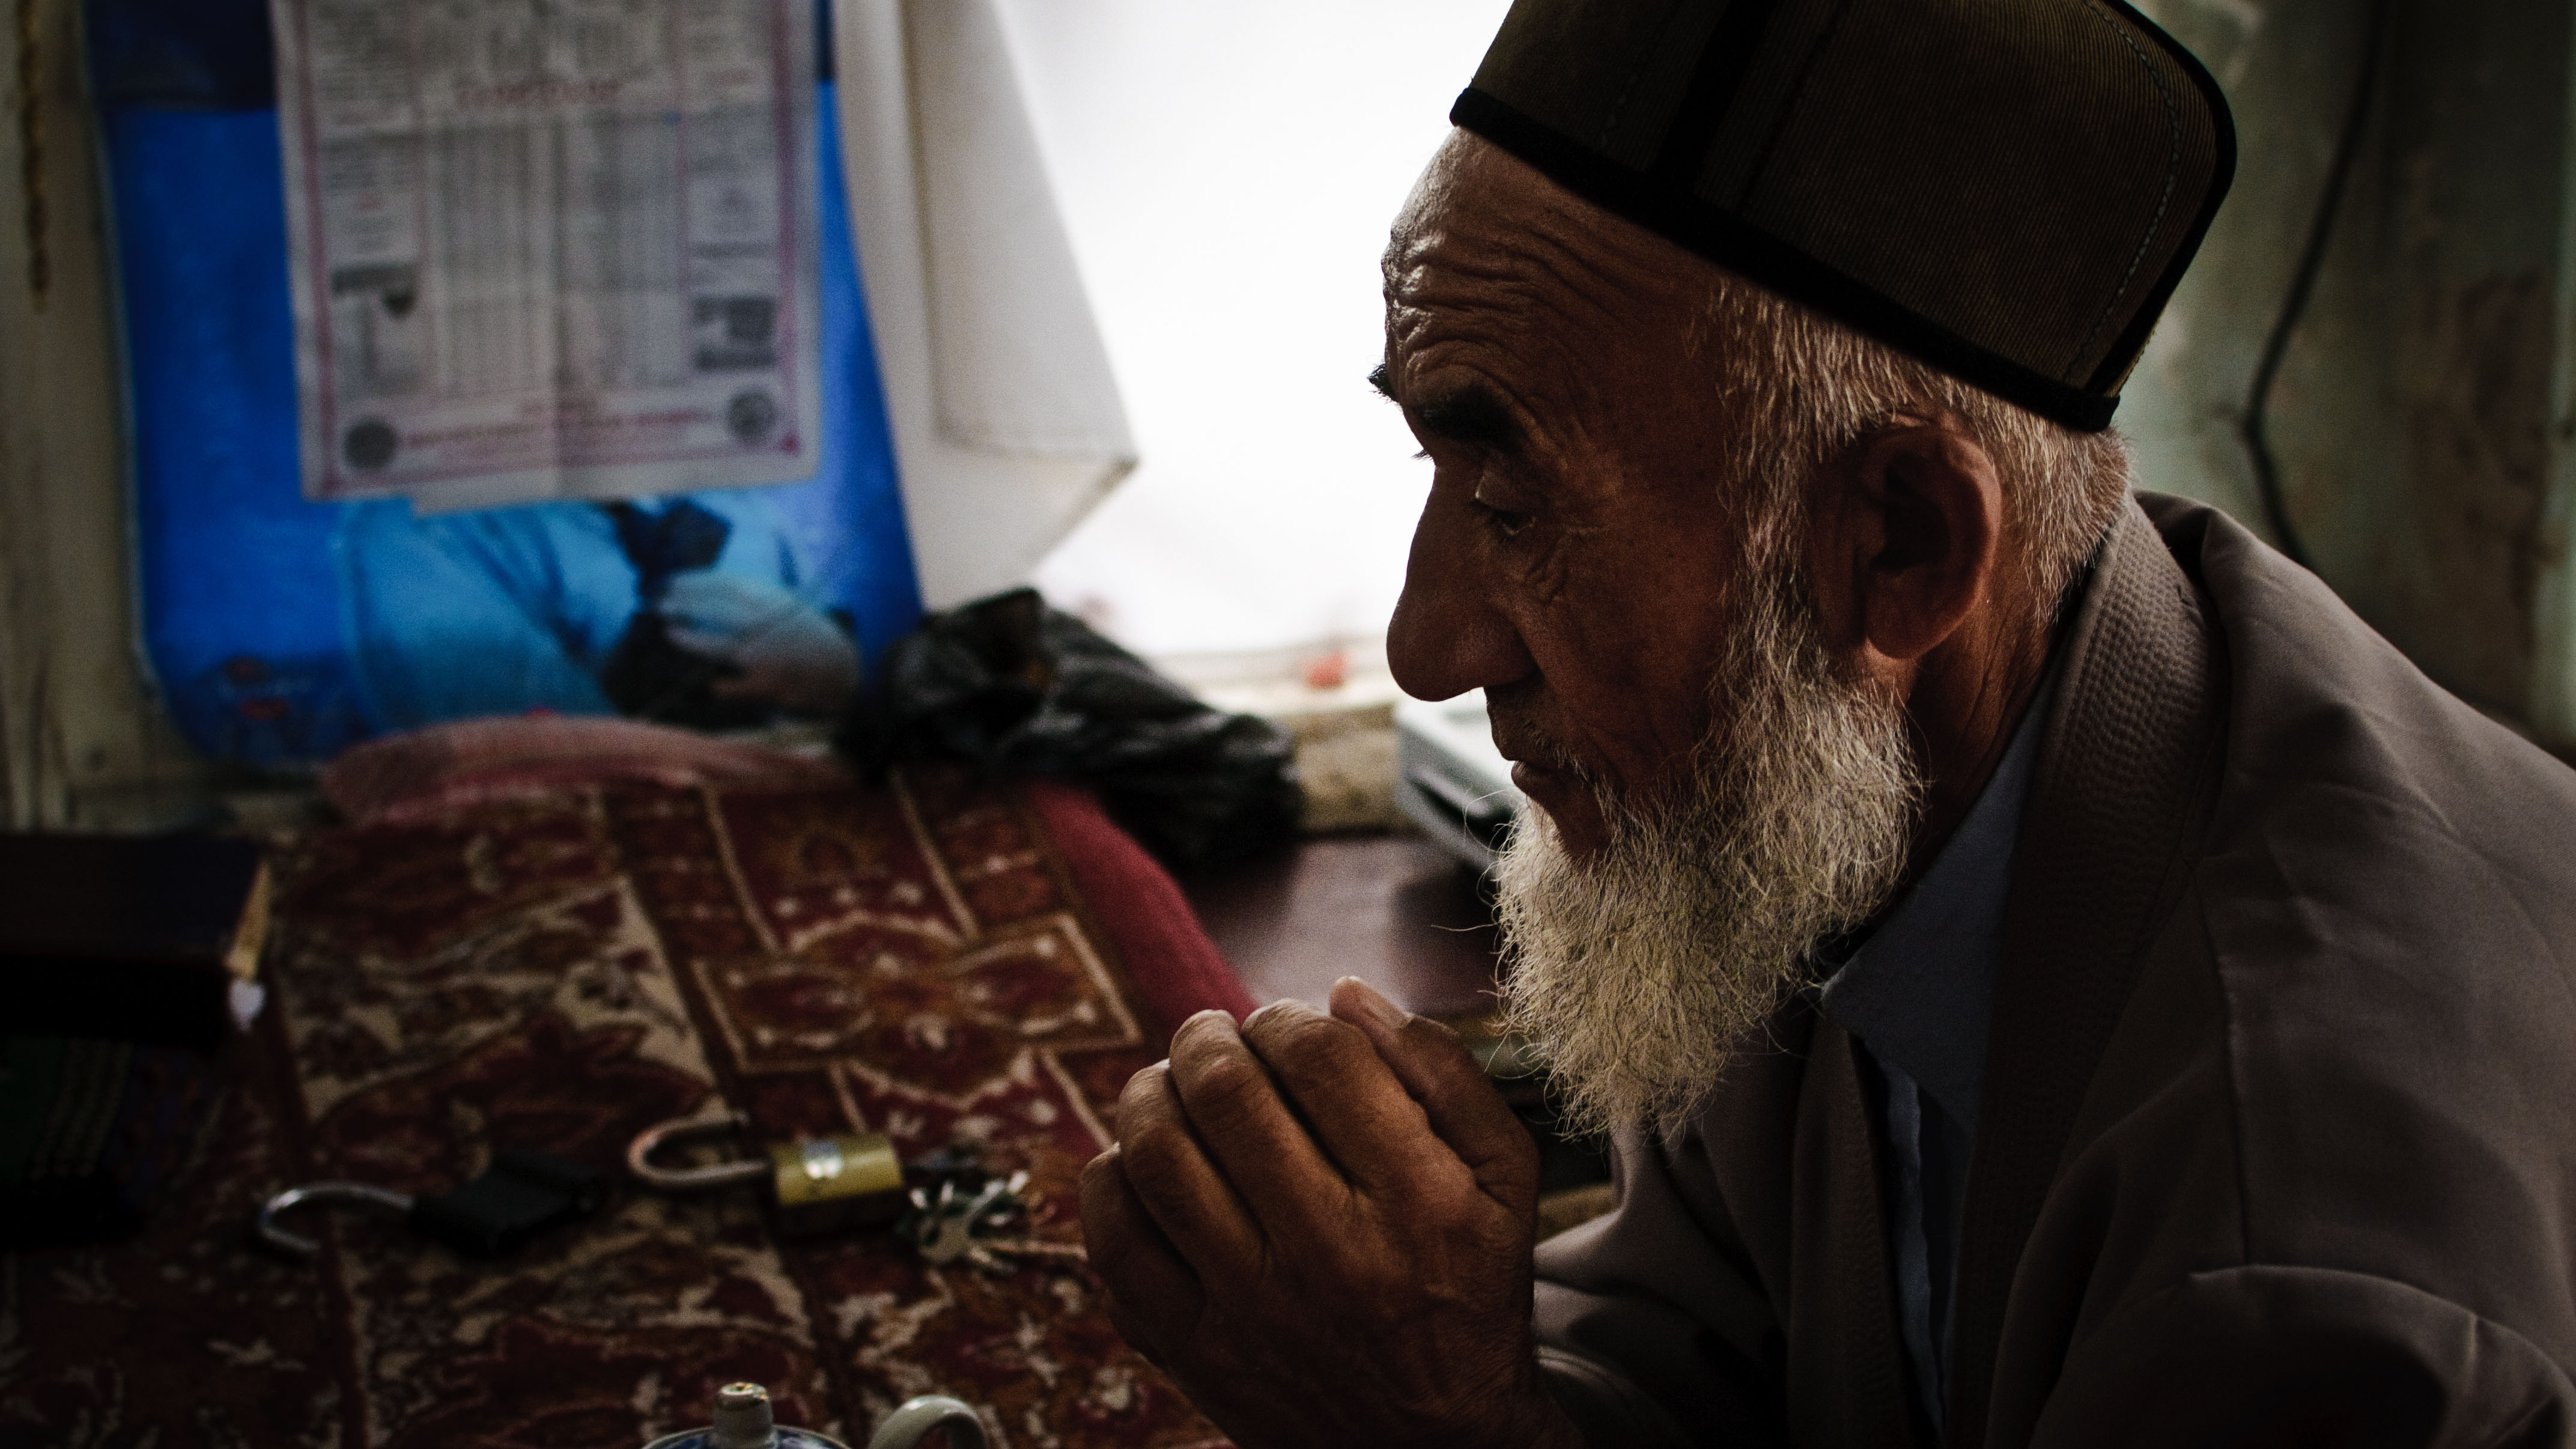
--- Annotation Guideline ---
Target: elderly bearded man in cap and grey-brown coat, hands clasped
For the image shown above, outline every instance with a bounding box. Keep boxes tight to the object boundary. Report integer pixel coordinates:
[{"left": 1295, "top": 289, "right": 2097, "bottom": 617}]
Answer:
[{"left": 1084, "top": 0, "right": 2576, "bottom": 1447}]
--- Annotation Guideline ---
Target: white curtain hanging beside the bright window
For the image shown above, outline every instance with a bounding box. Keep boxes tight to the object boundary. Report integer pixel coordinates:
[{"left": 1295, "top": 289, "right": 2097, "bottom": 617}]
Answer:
[{"left": 832, "top": 0, "right": 1136, "bottom": 609}]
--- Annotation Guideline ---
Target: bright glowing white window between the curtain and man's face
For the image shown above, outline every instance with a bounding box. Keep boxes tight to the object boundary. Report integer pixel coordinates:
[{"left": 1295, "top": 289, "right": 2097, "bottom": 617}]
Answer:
[{"left": 1002, "top": 0, "right": 1507, "bottom": 655}]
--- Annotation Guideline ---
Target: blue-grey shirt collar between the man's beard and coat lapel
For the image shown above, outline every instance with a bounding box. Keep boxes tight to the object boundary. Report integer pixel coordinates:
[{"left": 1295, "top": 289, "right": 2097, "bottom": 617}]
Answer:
[{"left": 1818, "top": 644, "right": 2061, "bottom": 1137}]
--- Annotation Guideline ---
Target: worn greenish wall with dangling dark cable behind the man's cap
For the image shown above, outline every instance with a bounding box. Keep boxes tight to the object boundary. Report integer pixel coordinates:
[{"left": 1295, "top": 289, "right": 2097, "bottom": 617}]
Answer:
[{"left": 2120, "top": 0, "right": 2576, "bottom": 727}]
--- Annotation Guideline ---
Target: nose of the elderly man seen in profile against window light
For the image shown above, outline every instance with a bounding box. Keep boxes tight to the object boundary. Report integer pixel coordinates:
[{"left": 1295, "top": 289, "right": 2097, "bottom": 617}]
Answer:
[{"left": 1386, "top": 487, "right": 1538, "bottom": 699}]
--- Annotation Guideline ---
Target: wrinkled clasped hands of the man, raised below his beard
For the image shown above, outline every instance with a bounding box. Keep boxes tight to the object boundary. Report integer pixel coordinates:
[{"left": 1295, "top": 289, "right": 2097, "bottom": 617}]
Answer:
[{"left": 1082, "top": 977, "right": 1574, "bottom": 1449}]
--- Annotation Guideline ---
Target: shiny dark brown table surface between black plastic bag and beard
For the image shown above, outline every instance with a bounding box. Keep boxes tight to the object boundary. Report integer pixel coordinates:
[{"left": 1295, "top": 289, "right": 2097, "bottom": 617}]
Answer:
[{"left": 1180, "top": 836, "right": 1496, "bottom": 1021}]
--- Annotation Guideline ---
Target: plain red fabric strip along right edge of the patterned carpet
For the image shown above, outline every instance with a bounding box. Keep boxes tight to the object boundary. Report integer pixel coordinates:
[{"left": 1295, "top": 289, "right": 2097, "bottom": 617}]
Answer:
[{"left": 1028, "top": 781, "right": 1254, "bottom": 1036}]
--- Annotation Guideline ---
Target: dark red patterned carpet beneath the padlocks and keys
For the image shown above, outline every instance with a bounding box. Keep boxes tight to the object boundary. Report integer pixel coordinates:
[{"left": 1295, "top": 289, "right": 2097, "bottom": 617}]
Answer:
[{"left": 0, "top": 779, "right": 1247, "bottom": 1449}]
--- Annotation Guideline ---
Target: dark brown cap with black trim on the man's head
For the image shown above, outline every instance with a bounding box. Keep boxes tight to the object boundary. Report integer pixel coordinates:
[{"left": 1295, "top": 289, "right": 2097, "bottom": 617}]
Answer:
[{"left": 1450, "top": 0, "right": 2236, "bottom": 431}]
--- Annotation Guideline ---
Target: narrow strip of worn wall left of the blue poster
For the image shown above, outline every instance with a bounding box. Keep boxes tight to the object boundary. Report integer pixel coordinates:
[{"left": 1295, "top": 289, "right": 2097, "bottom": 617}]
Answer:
[{"left": 0, "top": 0, "right": 204, "bottom": 828}]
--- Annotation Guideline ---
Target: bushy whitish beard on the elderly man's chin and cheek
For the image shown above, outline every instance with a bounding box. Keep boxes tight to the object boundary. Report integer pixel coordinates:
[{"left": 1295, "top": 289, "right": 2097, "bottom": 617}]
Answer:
[{"left": 1499, "top": 567, "right": 1922, "bottom": 1134}]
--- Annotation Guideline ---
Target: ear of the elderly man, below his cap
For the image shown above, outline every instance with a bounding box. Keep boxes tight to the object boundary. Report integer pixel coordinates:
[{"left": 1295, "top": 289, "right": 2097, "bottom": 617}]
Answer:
[{"left": 1808, "top": 421, "right": 2004, "bottom": 668}]
